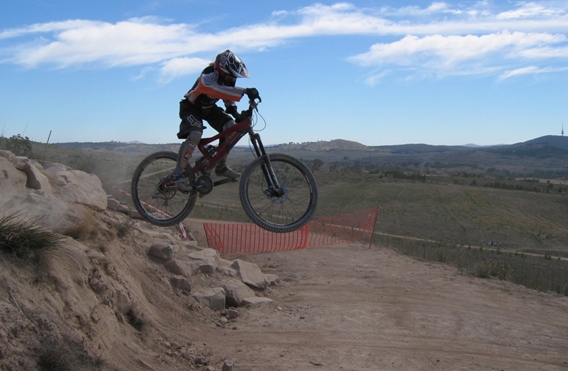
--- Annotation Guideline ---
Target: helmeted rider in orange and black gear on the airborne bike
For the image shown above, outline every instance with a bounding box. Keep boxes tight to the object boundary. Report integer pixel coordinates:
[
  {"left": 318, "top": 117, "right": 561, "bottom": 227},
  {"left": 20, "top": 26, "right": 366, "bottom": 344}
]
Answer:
[{"left": 172, "top": 50, "right": 258, "bottom": 188}]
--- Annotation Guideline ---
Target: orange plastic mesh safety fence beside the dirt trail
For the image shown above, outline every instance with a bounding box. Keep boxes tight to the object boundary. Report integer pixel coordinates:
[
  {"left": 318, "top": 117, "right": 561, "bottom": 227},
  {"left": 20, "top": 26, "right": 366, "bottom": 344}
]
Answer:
[{"left": 203, "top": 207, "right": 379, "bottom": 254}]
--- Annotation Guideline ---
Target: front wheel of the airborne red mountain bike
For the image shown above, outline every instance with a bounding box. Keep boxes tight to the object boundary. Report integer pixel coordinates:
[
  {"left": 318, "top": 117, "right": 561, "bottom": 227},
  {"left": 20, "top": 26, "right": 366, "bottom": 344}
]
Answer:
[{"left": 239, "top": 154, "right": 318, "bottom": 233}]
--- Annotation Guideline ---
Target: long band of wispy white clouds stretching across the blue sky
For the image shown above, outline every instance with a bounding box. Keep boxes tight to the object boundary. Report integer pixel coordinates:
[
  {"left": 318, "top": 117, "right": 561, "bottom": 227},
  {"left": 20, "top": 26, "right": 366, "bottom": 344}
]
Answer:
[{"left": 0, "top": 0, "right": 568, "bottom": 81}]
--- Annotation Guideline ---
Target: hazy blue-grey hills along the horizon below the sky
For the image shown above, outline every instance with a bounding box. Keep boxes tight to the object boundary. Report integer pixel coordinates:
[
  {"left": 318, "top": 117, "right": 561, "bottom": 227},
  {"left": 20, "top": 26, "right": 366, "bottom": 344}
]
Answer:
[{"left": 52, "top": 135, "right": 568, "bottom": 178}]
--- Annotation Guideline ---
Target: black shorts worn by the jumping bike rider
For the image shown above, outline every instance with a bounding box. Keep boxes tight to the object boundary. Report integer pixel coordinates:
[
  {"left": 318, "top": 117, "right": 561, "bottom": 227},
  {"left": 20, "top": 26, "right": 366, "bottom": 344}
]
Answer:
[{"left": 177, "top": 99, "right": 233, "bottom": 139}]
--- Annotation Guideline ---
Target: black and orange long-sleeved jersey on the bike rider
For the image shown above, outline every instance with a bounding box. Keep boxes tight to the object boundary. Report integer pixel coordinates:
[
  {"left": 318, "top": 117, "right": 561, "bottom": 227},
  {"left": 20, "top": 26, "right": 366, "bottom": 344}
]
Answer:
[{"left": 185, "top": 65, "right": 245, "bottom": 108}]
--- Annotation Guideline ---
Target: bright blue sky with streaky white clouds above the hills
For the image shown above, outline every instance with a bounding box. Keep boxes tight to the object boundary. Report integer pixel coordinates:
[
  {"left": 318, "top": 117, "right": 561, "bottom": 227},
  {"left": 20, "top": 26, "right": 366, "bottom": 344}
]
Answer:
[{"left": 0, "top": 0, "right": 568, "bottom": 145}]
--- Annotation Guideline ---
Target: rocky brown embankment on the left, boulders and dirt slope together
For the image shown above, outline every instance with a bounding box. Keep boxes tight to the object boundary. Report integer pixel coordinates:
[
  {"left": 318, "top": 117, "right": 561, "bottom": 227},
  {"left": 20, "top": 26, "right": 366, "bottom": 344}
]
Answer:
[{"left": 0, "top": 151, "right": 278, "bottom": 371}]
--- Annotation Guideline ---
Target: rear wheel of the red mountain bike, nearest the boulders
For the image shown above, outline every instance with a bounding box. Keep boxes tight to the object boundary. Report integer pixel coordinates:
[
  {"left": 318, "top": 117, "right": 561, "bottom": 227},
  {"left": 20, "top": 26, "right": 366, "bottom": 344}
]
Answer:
[{"left": 131, "top": 152, "right": 197, "bottom": 227}]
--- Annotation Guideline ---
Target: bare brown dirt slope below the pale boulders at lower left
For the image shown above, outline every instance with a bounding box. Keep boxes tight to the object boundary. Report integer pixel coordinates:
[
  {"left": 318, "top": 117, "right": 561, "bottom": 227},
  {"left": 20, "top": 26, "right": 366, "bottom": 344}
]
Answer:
[{"left": 0, "top": 212, "right": 237, "bottom": 370}]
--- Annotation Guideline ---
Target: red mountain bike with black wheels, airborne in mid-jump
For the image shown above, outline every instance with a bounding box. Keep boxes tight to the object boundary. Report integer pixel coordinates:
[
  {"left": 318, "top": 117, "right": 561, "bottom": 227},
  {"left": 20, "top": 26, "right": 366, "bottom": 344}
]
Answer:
[{"left": 131, "top": 97, "right": 318, "bottom": 233}]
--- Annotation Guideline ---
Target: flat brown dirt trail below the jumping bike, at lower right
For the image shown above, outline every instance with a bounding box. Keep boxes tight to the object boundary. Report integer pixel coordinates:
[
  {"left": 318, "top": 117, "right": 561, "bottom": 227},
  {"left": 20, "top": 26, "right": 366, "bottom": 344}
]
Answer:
[{"left": 207, "top": 244, "right": 568, "bottom": 370}]
